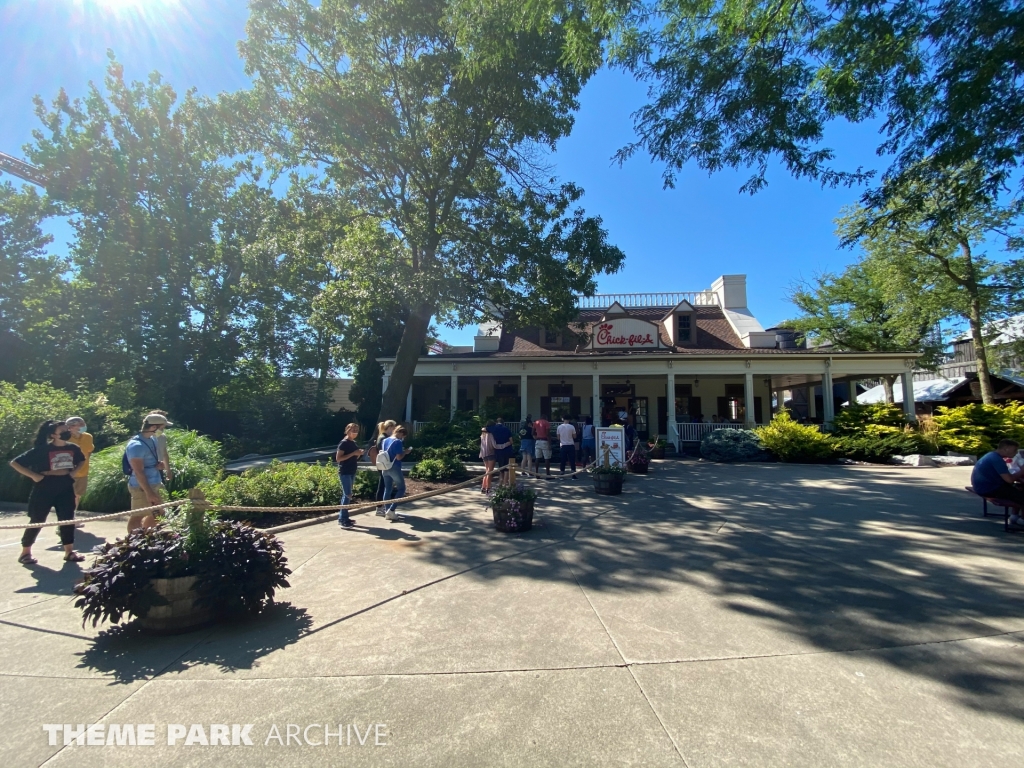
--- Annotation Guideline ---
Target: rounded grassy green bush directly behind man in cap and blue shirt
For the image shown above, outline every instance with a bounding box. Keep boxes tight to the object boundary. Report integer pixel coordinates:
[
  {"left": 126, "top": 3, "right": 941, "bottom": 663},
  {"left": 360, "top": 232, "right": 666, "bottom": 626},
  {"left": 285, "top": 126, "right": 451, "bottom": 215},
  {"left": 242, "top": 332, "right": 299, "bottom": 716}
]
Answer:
[{"left": 81, "top": 429, "right": 224, "bottom": 512}]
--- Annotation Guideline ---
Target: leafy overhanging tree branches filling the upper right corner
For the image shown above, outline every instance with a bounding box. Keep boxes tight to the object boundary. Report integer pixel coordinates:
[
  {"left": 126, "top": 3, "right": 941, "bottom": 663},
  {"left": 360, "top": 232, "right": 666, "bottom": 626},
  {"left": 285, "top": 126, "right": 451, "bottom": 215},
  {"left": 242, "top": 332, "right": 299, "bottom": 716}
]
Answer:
[{"left": 598, "top": 0, "right": 1024, "bottom": 198}]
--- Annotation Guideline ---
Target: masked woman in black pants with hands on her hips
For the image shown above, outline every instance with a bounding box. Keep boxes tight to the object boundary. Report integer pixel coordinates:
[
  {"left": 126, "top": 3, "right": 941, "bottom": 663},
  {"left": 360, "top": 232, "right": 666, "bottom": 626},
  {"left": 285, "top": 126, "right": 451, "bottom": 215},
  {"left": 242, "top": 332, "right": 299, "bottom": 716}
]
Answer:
[{"left": 10, "top": 420, "right": 85, "bottom": 565}]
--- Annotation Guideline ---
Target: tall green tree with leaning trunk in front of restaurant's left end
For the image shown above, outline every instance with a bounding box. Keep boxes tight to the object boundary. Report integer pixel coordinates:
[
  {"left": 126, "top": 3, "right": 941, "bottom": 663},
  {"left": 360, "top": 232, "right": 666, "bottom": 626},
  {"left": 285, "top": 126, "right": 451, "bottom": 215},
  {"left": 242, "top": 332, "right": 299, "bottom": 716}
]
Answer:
[{"left": 237, "top": 0, "right": 623, "bottom": 423}]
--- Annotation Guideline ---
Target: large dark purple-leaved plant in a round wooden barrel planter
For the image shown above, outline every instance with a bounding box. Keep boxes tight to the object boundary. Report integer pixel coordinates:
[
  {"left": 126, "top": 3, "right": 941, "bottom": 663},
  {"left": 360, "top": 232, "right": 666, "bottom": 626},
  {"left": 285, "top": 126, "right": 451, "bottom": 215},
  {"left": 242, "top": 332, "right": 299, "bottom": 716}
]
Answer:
[{"left": 75, "top": 510, "right": 292, "bottom": 634}]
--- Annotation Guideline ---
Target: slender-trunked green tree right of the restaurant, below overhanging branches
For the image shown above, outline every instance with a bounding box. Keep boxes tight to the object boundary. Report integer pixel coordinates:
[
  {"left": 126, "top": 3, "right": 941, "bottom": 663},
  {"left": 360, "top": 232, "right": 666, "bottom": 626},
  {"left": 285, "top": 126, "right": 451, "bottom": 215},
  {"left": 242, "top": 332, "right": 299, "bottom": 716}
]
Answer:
[{"left": 839, "top": 163, "right": 1024, "bottom": 404}]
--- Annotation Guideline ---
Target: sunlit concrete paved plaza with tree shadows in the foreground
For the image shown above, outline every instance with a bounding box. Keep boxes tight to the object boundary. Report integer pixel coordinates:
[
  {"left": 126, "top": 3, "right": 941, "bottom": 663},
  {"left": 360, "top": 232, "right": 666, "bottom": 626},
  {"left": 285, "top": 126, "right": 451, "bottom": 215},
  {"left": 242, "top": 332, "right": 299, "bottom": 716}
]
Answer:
[{"left": 0, "top": 462, "right": 1024, "bottom": 768}]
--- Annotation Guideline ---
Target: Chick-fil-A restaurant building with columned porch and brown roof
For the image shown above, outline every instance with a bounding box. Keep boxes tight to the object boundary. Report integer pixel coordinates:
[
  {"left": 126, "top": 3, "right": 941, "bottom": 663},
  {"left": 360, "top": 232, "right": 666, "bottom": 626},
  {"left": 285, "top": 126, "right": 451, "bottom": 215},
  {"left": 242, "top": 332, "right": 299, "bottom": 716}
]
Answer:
[{"left": 380, "top": 274, "right": 918, "bottom": 447}]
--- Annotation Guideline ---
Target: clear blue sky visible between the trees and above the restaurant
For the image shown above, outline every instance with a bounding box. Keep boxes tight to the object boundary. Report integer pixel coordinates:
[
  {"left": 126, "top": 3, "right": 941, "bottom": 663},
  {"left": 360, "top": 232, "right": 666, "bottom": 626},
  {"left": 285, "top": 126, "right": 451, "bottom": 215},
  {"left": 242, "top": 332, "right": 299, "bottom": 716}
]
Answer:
[{"left": 0, "top": 0, "right": 880, "bottom": 343}]
